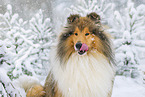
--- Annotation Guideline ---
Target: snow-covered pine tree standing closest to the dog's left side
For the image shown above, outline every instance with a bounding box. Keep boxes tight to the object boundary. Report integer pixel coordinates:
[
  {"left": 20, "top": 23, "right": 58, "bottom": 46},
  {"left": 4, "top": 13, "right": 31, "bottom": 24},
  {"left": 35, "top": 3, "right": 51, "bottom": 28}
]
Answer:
[{"left": 24, "top": 10, "right": 54, "bottom": 77}]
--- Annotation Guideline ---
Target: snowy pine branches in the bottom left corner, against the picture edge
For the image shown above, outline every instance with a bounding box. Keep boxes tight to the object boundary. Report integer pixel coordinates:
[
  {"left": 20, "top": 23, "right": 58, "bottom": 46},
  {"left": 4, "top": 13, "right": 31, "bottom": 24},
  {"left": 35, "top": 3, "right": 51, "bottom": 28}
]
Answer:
[{"left": 0, "top": 40, "right": 24, "bottom": 97}]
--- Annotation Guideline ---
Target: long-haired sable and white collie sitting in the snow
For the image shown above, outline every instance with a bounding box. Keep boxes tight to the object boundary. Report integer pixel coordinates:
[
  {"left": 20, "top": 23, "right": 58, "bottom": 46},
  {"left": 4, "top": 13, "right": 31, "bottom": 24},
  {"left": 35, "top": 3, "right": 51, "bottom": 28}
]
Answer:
[{"left": 27, "top": 12, "right": 115, "bottom": 97}]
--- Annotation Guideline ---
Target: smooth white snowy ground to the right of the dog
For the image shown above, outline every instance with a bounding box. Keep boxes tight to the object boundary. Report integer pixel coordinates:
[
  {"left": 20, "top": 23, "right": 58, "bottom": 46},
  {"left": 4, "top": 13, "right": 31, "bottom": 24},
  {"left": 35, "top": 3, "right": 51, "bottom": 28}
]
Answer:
[{"left": 112, "top": 76, "right": 145, "bottom": 97}]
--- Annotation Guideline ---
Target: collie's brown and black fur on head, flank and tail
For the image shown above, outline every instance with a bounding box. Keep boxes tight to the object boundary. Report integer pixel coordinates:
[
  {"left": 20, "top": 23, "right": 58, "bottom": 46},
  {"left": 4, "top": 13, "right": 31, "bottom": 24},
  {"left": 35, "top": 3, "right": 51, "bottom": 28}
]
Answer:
[{"left": 27, "top": 13, "right": 114, "bottom": 97}]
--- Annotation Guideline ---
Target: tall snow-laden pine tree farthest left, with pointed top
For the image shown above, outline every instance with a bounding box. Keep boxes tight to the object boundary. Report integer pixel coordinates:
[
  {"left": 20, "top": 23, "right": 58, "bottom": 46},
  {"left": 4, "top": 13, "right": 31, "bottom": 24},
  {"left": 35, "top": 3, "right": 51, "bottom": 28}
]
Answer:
[{"left": 1, "top": 5, "right": 36, "bottom": 79}]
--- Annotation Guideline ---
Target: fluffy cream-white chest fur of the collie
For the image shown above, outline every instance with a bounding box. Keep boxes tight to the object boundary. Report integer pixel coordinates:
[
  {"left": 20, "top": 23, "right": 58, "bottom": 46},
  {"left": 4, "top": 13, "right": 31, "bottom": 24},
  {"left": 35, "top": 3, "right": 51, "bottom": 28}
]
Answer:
[{"left": 51, "top": 52, "right": 114, "bottom": 97}]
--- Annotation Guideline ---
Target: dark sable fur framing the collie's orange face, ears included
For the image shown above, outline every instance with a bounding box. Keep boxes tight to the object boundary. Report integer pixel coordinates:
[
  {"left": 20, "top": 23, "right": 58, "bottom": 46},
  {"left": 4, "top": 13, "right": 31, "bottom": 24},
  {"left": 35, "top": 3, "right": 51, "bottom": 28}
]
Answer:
[{"left": 57, "top": 13, "right": 115, "bottom": 63}]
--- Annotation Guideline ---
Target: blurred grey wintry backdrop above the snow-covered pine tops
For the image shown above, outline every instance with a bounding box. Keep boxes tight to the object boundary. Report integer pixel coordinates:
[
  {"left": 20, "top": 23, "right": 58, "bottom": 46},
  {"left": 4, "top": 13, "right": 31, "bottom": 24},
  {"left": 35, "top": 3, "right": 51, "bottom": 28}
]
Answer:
[{"left": 0, "top": 0, "right": 145, "bottom": 20}]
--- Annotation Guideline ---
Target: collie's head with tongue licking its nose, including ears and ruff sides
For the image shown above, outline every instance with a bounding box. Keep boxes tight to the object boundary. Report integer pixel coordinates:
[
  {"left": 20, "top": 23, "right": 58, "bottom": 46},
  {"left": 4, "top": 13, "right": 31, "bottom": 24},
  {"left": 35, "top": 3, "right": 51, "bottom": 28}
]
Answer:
[{"left": 57, "top": 12, "right": 112, "bottom": 63}]
